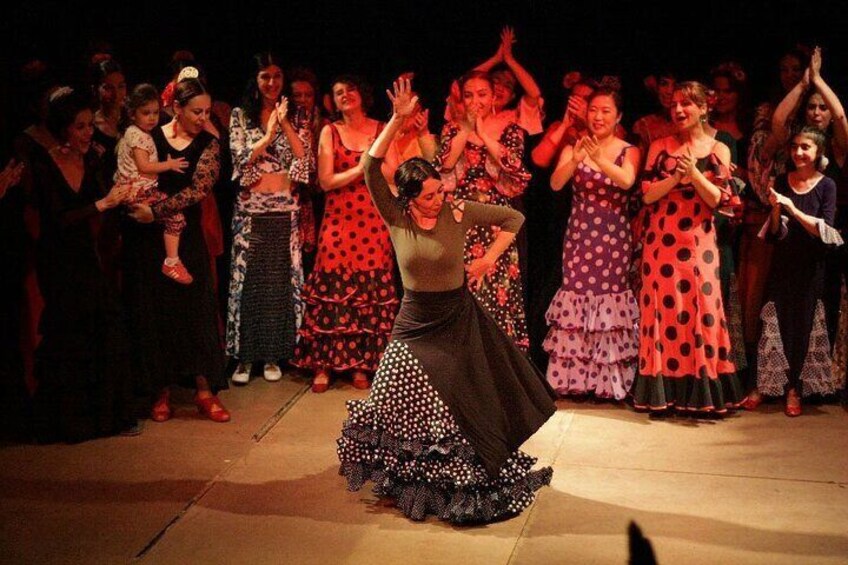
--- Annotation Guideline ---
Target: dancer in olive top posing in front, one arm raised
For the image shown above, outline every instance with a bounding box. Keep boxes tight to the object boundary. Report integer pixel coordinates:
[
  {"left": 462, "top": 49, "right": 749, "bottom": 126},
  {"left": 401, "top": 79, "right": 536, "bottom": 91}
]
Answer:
[{"left": 338, "top": 80, "right": 555, "bottom": 524}]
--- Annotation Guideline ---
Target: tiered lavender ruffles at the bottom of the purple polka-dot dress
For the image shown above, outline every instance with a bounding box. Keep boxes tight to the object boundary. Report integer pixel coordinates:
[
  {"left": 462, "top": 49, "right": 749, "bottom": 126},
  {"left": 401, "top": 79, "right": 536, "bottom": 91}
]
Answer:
[{"left": 543, "top": 289, "right": 639, "bottom": 400}]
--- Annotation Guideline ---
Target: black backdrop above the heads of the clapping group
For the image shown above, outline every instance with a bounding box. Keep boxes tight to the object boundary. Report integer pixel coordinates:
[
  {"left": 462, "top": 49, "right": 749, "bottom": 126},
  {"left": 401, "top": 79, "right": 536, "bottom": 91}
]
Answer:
[{"left": 0, "top": 0, "right": 848, "bottom": 140}]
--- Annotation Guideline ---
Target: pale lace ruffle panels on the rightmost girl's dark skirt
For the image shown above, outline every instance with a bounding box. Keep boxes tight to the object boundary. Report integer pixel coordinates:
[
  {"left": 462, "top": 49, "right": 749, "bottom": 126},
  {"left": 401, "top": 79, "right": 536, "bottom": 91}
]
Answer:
[{"left": 757, "top": 300, "right": 838, "bottom": 396}]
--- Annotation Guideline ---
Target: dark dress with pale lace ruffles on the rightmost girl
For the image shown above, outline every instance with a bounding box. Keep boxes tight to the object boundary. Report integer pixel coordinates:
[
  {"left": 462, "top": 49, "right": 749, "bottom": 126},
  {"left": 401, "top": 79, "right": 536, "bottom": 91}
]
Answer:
[{"left": 757, "top": 174, "right": 836, "bottom": 396}]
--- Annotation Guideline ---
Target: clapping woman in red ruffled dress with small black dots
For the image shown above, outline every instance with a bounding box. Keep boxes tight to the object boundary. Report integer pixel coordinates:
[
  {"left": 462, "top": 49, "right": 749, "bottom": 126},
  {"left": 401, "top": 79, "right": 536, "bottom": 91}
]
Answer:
[{"left": 293, "top": 76, "right": 397, "bottom": 392}]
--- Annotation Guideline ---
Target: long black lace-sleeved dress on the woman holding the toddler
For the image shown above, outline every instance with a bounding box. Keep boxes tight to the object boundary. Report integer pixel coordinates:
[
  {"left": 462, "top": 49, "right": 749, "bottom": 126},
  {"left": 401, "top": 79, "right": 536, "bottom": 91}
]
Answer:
[{"left": 123, "top": 128, "right": 227, "bottom": 400}]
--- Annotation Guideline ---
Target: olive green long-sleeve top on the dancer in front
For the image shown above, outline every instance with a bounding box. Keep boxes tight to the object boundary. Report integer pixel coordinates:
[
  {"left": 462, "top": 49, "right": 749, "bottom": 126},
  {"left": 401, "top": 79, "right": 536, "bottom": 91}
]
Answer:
[{"left": 363, "top": 154, "right": 524, "bottom": 292}]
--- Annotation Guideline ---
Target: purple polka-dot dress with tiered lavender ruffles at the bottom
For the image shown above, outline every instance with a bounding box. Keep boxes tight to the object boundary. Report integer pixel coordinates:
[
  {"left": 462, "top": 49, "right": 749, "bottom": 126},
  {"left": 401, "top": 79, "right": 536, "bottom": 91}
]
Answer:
[{"left": 543, "top": 146, "right": 639, "bottom": 400}]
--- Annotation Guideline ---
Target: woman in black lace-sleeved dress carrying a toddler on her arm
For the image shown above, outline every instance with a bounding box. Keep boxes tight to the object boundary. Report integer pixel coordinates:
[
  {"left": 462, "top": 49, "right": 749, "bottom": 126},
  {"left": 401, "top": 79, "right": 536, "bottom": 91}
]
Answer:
[{"left": 123, "top": 78, "right": 230, "bottom": 422}]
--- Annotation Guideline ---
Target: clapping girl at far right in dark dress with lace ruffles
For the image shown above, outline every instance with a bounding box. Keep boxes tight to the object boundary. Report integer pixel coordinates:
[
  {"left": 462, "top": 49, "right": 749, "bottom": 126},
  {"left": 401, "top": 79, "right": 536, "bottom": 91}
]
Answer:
[{"left": 743, "top": 126, "right": 842, "bottom": 416}]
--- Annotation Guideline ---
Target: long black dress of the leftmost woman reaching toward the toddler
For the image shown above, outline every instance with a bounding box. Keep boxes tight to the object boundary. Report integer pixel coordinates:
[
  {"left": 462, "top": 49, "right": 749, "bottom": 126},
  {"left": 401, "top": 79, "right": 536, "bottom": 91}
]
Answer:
[{"left": 32, "top": 148, "right": 135, "bottom": 442}]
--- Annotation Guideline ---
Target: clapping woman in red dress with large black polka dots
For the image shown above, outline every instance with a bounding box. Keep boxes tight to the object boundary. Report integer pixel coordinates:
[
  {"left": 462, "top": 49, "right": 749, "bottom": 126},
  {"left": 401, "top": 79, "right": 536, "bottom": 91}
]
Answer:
[{"left": 632, "top": 82, "right": 743, "bottom": 414}]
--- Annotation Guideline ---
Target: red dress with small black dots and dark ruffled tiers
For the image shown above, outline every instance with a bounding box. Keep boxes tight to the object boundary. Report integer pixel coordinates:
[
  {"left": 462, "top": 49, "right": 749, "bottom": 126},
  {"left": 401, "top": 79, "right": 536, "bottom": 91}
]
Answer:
[{"left": 292, "top": 124, "right": 398, "bottom": 371}]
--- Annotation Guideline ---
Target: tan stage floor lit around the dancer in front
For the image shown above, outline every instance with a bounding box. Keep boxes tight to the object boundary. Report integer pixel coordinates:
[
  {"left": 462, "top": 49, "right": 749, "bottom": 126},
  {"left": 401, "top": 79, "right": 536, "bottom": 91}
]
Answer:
[{"left": 0, "top": 374, "right": 848, "bottom": 565}]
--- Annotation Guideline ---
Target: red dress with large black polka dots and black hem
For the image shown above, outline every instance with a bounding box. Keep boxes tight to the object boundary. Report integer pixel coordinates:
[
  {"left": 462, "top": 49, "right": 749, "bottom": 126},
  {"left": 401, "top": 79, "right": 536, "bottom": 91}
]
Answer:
[{"left": 632, "top": 150, "right": 744, "bottom": 413}]
